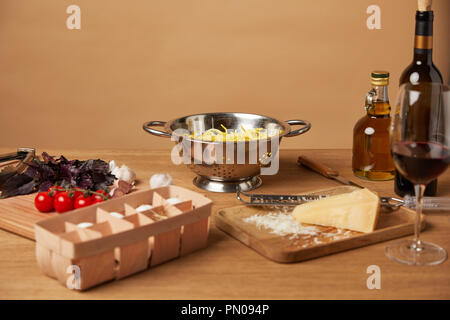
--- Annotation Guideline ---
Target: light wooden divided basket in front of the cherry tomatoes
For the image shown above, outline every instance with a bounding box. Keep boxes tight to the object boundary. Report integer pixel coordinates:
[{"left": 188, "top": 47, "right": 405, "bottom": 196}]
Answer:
[{"left": 35, "top": 186, "right": 212, "bottom": 290}]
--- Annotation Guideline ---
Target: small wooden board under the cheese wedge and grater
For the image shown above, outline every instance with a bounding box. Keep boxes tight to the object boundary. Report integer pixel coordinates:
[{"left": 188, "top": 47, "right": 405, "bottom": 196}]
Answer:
[{"left": 215, "top": 186, "right": 425, "bottom": 263}]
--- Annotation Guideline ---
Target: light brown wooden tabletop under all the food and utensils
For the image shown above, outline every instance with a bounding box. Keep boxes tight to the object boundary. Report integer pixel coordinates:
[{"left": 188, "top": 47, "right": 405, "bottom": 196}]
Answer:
[{"left": 0, "top": 149, "right": 450, "bottom": 299}]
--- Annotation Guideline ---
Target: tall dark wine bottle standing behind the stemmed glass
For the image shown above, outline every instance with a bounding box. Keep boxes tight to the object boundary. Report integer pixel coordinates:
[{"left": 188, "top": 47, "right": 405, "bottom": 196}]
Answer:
[{"left": 394, "top": 2, "right": 443, "bottom": 197}]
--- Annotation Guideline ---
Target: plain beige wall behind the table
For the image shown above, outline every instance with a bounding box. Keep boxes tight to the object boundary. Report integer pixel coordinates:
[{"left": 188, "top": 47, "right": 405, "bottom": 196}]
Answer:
[{"left": 0, "top": 0, "right": 450, "bottom": 151}]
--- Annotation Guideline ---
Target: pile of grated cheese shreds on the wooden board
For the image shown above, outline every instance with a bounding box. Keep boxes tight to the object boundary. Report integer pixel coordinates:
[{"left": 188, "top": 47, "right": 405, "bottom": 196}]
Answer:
[{"left": 243, "top": 212, "right": 319, "bottom": 239}]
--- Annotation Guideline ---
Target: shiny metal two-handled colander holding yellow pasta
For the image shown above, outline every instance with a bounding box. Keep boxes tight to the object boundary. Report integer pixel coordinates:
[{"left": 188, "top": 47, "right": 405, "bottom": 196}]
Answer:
[{"left": 143, "top": 112, "right": 311, "bottom": 192}]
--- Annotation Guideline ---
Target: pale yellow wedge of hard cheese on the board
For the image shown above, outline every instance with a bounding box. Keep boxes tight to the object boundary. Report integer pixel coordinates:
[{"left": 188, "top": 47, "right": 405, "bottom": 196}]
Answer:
[{"left": 292, "top": 189, "right": 380, "bottom": 232}]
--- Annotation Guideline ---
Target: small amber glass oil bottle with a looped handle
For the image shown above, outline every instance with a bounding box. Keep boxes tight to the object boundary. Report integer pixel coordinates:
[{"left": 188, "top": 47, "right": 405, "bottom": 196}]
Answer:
[{"left": 352, "top": 71, "right": 395, "bottom": 180}]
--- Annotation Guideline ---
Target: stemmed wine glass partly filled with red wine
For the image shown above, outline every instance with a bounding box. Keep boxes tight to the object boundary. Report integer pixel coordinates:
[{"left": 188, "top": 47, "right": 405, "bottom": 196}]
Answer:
[{"left": 386, "top": 83, "right": 450, "bottom": 265}]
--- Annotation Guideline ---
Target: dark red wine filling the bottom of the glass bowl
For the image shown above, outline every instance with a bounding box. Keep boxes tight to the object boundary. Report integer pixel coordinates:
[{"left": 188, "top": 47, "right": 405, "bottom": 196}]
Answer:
[{"left": 392, "top": 141, "right": 450, "bottom": 185}]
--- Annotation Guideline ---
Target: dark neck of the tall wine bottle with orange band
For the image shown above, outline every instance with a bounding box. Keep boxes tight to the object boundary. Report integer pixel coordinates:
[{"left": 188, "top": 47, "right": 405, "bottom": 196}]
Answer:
[{"left": 414, "top": 11, "right": 434, "bottom": 65}]
